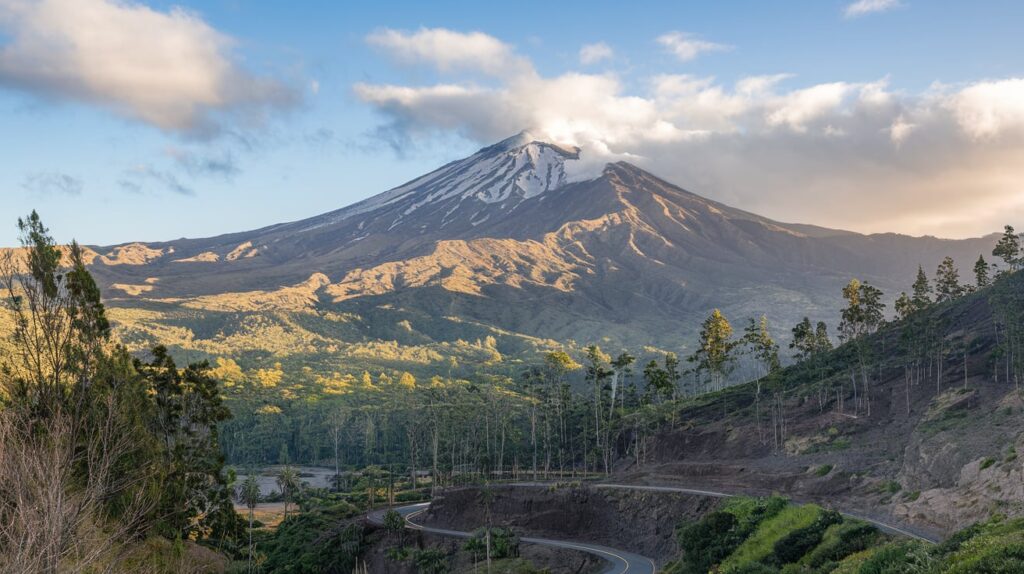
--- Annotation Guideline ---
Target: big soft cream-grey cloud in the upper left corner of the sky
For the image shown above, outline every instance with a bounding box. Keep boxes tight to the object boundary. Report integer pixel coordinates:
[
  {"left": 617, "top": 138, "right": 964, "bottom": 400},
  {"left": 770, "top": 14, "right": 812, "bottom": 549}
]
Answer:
[{"left": 0, "top": 0, "right": 296, "bottom": 134}]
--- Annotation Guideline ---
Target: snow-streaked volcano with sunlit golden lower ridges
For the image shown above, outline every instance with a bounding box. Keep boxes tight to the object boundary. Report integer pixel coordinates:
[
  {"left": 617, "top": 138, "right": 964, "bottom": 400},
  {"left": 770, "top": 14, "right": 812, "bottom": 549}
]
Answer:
[{"left": 24, "top": 132, "right": 994, "bottom": 388}]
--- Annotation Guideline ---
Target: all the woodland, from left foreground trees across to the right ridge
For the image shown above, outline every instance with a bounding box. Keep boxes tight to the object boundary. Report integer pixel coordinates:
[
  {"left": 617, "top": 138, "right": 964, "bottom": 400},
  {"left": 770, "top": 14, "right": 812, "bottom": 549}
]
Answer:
[{"left": 0, "top": 213, "right": 1024, "bottom": 573}]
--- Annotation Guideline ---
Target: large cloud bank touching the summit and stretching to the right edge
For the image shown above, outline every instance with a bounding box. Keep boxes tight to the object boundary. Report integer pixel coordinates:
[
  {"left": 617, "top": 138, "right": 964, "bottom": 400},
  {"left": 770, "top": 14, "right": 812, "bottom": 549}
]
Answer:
[{"left": 355, "top": 26, "right": 1024, "bottom": 236}]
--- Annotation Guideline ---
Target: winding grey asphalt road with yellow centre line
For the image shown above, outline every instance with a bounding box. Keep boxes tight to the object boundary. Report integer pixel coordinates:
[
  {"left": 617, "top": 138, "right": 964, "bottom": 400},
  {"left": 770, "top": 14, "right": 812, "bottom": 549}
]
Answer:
[{"left": 368, "top": 482, "right": 939, "bottom": 574}]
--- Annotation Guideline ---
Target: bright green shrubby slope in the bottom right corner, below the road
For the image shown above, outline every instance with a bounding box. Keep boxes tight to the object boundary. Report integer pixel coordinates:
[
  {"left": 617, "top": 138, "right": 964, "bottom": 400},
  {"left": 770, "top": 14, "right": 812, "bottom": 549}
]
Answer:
[{"left": 664, "top": 497, "right": 1024, "bottom": 574}]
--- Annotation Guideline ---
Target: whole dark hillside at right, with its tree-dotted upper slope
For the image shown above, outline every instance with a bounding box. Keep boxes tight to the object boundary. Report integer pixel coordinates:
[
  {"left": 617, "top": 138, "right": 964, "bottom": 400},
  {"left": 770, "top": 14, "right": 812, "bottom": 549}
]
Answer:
[{"left": 620, "top": 266, "right": 1024, "bottom": 534}]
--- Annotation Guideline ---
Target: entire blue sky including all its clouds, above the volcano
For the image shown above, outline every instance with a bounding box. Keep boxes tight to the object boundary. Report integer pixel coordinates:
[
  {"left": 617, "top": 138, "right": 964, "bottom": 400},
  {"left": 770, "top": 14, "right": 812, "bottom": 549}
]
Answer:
[{"left": 0, "top": 0, "right": 1024, "bottom": 245}]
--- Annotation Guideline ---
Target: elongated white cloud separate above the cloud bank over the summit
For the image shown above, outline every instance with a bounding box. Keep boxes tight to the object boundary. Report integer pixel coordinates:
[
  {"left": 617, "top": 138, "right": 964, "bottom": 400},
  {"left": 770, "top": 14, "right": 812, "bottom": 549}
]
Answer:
[{"left": 367, "top": 28, "right": 532, "bottom": 77}]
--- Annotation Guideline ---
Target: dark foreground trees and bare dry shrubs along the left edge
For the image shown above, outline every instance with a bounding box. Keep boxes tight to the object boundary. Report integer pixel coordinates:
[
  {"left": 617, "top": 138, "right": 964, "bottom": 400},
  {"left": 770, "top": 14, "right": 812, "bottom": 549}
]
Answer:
[{"left": 0, "top": 213, "right": 243, "bottom": 573}]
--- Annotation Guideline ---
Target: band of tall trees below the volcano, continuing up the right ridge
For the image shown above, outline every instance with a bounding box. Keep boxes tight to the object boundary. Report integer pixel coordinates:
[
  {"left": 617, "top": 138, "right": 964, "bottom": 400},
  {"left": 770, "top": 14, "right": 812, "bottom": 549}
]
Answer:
[{"left": 213, "top": 226, "right": 1024, "bottom": 484}]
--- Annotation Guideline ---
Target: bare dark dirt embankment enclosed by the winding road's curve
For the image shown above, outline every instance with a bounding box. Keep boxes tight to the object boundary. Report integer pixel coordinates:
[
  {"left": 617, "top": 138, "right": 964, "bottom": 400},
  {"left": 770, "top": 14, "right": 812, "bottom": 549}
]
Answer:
[{"left": 419, "top": 486, "right": 720, "bottom": 560}]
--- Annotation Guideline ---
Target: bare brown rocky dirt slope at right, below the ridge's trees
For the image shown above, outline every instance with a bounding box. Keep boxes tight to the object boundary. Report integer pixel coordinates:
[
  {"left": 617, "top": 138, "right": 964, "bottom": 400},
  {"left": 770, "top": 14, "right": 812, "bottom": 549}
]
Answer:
[{"left": 615, "top": 327, "right": 1024, "bottom": 535}]
